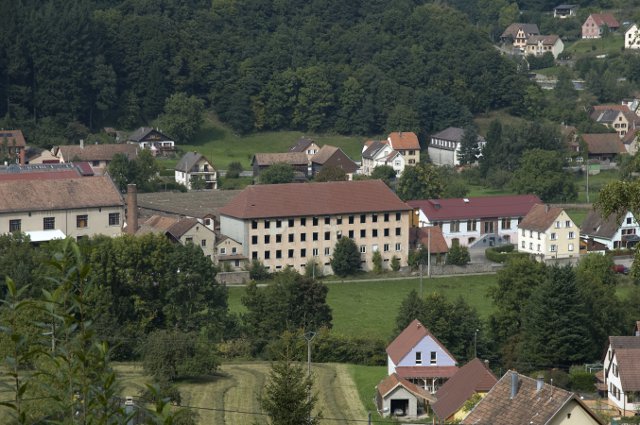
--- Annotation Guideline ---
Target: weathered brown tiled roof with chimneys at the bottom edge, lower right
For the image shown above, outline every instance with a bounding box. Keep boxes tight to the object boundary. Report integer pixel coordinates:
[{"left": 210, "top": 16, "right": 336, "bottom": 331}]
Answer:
[{"left": 461, "top": 370, "right": 604, "bottom": 425}]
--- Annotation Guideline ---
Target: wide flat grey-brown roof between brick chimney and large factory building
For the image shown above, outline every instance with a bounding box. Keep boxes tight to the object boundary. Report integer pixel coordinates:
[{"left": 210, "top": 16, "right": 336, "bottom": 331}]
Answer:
[{"left": 138, "top": 190, "right": 240, "bottom": 218}]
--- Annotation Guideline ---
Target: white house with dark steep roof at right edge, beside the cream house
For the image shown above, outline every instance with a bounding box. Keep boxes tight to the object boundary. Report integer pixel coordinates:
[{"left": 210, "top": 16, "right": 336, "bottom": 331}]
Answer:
[{"left": 580, "top": 210, "right": 640, "bottom": 249}]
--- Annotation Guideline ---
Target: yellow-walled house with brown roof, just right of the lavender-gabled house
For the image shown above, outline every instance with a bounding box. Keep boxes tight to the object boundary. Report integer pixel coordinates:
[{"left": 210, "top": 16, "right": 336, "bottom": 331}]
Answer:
[{"left": 433, "top": 358, "right": 498, "bottom": 424}]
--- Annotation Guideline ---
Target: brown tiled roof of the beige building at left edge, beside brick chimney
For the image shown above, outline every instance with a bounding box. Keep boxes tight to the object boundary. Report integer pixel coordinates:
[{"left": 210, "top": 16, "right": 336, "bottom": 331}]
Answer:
[{"left": 0, "top": 176, "right": 124, "bottom": 212}]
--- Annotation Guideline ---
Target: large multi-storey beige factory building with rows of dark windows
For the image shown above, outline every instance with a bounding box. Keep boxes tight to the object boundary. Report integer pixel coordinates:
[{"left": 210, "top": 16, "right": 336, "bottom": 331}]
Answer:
[{"left": 219, "top": 180, "right": 411, "bottom": 273}]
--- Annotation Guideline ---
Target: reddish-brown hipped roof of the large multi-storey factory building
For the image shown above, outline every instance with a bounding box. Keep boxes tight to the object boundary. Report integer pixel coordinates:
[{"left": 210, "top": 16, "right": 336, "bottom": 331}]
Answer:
[{"left": 220, "top": 180, "right": 410, "bottom": 219}]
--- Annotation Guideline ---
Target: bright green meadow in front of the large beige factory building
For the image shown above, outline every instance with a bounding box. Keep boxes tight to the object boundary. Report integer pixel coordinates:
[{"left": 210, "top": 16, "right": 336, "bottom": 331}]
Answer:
[{"left": 229, "top": 275, "right": 496, "bottom": 341}]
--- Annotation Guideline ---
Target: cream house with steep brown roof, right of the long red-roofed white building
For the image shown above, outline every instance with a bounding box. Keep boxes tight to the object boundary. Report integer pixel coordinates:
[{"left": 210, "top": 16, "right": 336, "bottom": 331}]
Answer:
[{"left": 517, "top": 204, "right": 580, "bottom": 261}]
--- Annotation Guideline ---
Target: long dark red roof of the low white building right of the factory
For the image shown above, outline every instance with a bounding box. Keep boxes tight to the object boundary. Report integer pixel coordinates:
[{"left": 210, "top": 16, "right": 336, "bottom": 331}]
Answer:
[{"left": 407, "top": 195, "right": 542, "bottom": 221}]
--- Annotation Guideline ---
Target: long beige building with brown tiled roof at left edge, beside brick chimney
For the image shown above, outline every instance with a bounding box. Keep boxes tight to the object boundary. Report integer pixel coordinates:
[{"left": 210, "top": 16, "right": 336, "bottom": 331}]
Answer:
[{"left": 0, "top": 176, "right": 125, "bottom": 240}]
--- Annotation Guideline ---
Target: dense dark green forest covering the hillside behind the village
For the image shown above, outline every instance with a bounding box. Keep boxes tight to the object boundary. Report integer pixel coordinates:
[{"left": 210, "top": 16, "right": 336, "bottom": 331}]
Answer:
[{"left": 0, "top": 0, "right": 526, "bottom": 146}]
